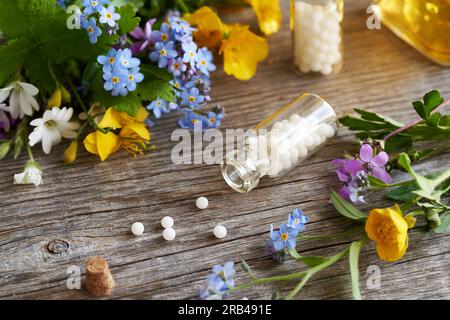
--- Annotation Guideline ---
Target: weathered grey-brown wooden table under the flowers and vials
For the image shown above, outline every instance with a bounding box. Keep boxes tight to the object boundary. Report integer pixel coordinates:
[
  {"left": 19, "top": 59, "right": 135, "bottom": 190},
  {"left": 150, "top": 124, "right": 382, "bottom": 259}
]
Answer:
[{"left": 0, "top": 0, "right": 450, "bottom": 299}]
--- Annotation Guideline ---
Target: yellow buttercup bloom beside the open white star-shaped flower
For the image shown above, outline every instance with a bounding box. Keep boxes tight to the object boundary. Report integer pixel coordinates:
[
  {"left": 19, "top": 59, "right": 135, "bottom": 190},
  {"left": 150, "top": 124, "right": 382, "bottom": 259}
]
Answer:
[{"left": 83, "top": 107, "right": 150, "bottom": 161}]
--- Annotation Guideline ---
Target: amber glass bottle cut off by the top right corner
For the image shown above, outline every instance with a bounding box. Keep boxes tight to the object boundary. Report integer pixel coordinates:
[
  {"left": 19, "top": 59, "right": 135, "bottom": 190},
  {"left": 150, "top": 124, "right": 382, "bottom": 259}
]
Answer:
[{"left": 374, "top": 0, "right": 450, "bottom": 66}]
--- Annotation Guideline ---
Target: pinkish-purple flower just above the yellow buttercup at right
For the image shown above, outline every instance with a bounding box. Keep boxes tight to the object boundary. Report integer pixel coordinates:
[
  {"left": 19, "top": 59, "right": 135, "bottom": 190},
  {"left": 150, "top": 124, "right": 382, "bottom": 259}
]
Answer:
[{"left": 359, "top": 144, "right": 392, "bottom": 184}]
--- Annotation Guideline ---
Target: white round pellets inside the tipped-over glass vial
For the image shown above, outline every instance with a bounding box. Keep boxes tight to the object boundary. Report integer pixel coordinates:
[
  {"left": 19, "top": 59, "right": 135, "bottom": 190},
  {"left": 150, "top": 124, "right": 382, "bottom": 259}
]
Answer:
[{"left": 246, "top": 114, "right": 336, "bottom": 178}]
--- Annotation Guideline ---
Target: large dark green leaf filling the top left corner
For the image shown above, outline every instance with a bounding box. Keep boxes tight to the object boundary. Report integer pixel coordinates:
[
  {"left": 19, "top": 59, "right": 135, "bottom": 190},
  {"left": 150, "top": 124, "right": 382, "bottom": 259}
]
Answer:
[{"left": 0, "top": 0, "right": 121, "bottom": 94}]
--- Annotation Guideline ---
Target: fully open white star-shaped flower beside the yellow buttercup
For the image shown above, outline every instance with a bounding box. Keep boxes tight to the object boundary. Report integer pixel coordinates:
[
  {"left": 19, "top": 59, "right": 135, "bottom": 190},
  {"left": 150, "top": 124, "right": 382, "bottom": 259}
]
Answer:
[{"left": 28, "top": 107, "right": 79, "bottom": 154}]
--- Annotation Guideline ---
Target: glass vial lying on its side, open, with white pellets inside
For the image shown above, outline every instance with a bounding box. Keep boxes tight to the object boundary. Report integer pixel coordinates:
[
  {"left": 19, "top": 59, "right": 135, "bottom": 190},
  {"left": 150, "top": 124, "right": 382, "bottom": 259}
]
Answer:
[{"left": 221, "top": 93, "right": 337, "bottom": 193}]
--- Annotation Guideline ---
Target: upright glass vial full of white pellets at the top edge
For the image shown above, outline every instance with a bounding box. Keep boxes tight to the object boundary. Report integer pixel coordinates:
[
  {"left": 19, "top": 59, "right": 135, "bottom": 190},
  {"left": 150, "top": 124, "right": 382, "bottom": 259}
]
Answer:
[{"left": 291, "top": 0, "right": 344, "bottom": 75}]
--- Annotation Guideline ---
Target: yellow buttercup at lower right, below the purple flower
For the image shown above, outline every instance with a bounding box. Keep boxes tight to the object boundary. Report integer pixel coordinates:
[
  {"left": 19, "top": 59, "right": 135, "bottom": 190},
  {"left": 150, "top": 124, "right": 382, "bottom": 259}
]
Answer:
[{"left": 366, "top": 205, "right": 415, "bottom": 262}]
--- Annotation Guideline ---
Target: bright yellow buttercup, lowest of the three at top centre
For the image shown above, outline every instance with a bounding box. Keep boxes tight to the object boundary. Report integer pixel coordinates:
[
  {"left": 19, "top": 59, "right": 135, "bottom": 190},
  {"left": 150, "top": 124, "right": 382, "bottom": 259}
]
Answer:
[{"left": 220, "top": 24, "right": 269, "bottom": 80}]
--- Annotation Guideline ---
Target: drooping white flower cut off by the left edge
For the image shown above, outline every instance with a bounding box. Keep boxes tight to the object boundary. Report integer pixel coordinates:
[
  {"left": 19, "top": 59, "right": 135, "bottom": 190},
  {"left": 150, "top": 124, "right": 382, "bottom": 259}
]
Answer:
[{"left": 0, "top": 81, "right": 39, "bottom": 119}]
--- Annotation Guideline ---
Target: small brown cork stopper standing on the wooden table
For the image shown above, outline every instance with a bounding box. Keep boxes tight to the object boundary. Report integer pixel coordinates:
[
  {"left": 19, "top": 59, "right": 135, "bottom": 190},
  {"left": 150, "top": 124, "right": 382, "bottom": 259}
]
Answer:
[{"left": 85, "top": 257, "right": 115, "bottom": 297}]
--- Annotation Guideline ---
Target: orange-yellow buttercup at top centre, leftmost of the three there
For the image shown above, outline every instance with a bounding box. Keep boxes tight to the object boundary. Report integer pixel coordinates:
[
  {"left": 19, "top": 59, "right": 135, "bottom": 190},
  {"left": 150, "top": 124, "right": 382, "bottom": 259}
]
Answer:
[{"left": 184, "top": 6, "right": 224, "bottom": 50}]
